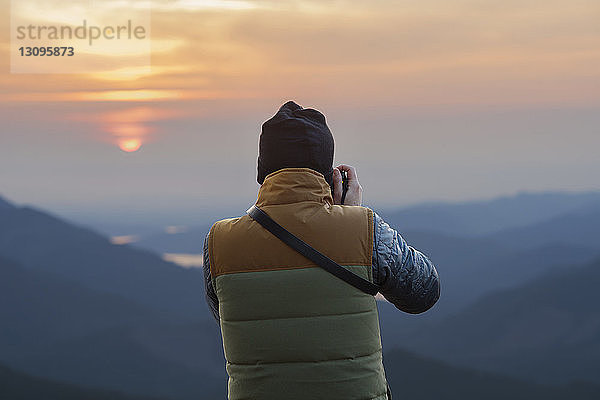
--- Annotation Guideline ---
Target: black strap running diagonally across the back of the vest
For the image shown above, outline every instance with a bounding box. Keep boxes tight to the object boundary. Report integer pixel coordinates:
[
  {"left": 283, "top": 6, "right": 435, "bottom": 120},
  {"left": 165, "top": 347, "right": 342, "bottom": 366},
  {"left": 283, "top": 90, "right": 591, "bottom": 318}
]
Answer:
[{"left": 246, "top": 205, "right": 379, "bottom": 296}]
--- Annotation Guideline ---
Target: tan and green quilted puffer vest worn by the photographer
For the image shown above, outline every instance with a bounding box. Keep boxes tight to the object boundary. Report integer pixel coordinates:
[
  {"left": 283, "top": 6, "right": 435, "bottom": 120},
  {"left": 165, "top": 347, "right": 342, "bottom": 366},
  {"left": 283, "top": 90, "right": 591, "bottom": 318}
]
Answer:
[{"left": 208, "top": 168, "right": 386, "bottom": 400}]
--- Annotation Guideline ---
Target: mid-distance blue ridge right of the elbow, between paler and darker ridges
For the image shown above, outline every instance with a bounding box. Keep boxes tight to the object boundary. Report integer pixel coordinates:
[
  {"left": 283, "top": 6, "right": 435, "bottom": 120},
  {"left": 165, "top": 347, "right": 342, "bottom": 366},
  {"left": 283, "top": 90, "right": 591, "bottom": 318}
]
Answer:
[{"left": 380, "top": 195, "right": 600, "bottom": 318}]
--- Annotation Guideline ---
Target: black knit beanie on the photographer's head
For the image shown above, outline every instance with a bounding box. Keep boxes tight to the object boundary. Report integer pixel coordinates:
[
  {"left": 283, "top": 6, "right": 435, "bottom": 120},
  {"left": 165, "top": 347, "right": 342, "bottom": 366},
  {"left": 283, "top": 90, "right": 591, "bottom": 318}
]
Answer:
[{"left": 257, "top": 101, "right": 334, "bottom": 186}]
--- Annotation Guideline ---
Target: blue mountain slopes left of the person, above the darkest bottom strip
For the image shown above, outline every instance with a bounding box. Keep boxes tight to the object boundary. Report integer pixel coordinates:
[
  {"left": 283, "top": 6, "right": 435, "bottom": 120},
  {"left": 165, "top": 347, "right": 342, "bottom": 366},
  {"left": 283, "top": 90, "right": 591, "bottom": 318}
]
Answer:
[{"left": 0, "top": 202, "right": 226, "bottom": 398}]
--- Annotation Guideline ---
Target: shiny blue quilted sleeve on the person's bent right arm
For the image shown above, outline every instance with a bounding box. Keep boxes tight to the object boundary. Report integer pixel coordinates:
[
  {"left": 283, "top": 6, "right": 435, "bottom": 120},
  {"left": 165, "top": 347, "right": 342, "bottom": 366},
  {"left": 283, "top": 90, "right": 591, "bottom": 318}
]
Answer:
[{"left": 373, "top": 213, "right": 440, "bottom": 314}]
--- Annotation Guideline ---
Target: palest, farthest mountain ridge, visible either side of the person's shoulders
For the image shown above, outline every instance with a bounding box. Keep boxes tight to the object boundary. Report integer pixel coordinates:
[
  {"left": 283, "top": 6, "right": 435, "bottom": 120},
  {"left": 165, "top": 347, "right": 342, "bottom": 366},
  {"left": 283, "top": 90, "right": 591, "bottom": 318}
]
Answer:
[{"left": 130, "top": 192, "right": 600, "bottom": 253}]
